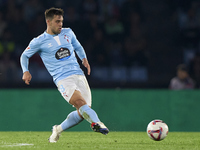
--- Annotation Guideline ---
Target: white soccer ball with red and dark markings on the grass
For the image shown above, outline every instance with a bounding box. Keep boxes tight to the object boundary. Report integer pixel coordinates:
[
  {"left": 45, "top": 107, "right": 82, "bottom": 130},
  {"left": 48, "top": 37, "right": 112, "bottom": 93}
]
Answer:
[{"left": 147, "top": 119, "right": 169, "bottom": 141}]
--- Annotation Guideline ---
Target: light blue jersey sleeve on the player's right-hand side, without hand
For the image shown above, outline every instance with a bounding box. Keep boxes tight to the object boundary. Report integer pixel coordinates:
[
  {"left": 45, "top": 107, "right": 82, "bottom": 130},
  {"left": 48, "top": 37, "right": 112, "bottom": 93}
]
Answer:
[{"left": 71, "top": 30, "right": 87, "bottom": 60}]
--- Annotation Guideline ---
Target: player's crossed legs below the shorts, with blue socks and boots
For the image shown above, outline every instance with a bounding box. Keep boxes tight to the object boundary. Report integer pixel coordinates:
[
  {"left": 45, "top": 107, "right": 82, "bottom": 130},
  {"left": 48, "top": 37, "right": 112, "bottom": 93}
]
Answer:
[{"left": 49, "top": 91, "right": 109, "bottom": 143}]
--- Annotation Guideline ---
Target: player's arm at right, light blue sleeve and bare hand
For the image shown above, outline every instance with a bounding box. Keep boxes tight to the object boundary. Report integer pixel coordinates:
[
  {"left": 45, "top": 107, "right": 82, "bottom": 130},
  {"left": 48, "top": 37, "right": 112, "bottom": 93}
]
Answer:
[{"left": 72, "top": 28, "right": 91, "bottom": 75}]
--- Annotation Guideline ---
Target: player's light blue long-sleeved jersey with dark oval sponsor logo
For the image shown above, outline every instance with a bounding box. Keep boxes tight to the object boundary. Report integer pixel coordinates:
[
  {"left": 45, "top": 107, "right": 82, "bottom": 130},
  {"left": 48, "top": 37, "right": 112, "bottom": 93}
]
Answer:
[{"left": 20, "top": 28, "right": 86, "bottom": 84}]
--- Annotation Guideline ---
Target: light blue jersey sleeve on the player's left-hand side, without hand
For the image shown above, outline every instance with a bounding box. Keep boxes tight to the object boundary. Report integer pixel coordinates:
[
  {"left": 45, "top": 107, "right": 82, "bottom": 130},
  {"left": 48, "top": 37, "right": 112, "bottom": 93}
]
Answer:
[{"left": 20, "top": 38, "right": 40, "bottom": 73}]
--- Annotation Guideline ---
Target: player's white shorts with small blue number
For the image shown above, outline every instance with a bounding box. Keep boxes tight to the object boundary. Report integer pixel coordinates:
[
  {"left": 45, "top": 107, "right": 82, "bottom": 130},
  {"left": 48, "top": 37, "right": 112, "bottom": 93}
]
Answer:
[{"left": 57, "top": 75, "right": 92, "bottom": 106}]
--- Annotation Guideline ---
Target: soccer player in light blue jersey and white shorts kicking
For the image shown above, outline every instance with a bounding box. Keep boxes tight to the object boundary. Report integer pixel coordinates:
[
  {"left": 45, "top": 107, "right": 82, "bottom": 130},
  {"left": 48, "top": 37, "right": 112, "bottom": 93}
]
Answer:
[{"left": 20, "top": 8, "right": 109, "bottom": 143}]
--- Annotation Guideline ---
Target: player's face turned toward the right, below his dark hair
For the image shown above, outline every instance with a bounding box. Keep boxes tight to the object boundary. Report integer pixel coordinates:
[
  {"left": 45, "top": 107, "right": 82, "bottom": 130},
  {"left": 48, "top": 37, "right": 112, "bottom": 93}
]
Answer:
[{"left": 49, "top": 15, "right": 63, "bottom": 34}]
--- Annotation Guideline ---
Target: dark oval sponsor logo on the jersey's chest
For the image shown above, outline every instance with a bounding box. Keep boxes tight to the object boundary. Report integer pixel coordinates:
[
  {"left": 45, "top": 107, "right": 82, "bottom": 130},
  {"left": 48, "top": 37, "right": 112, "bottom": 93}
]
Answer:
[{"left": 55, "top": 47, "right": 71, "bottom": 60}]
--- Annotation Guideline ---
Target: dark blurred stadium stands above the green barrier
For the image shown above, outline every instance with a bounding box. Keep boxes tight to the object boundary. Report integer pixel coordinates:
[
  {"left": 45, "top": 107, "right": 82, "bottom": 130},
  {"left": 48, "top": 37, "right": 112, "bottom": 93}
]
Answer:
[{"left": 0, "top": 0, "right": 200, "bottom": 88}]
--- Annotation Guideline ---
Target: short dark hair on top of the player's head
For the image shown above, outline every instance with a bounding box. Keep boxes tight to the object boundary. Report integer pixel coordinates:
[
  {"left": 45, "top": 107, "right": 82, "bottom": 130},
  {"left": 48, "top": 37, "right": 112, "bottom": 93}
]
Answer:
[{"left": 44, "top": 7, "right": 64, "bottom": 19}]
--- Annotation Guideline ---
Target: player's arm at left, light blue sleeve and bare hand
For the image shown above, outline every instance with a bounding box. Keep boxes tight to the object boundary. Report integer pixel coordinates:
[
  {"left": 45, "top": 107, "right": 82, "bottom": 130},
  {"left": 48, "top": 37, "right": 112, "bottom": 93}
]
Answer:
[{"left": 20, "top": 39, "right": 39, "bottom": 85}]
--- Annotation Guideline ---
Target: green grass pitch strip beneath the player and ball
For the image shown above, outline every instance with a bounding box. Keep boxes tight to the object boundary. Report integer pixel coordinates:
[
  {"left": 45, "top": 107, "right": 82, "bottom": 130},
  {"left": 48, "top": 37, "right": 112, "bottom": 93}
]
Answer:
[{"left": 0, "top": 131, "right": 200, "bottom": 150}]
